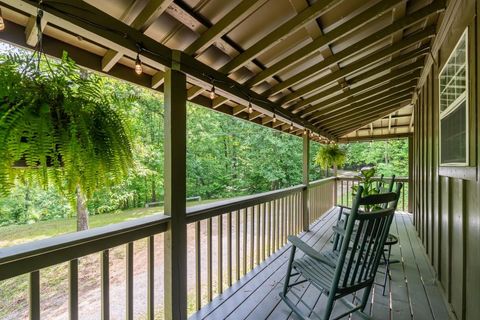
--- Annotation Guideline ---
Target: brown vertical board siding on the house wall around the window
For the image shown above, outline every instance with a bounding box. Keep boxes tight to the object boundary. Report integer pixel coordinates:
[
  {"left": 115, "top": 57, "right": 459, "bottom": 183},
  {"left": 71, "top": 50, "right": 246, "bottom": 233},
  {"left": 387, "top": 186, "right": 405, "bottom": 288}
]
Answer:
[{"left": 411, "top": 0, "right": 480, "bottom": 319}]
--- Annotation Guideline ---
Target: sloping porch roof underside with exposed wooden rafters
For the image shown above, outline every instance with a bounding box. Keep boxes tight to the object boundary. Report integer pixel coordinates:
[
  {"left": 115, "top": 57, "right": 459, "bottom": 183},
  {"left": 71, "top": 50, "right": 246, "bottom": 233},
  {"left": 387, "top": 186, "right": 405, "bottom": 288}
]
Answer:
[{"left": 0, "top": 0, "right": 445, "bottom": 141}]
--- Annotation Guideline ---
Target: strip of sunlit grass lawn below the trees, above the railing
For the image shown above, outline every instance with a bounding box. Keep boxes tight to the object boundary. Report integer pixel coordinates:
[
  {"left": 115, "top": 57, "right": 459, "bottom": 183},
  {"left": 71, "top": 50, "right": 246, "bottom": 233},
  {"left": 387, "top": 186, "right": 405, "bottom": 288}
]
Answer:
[{"left": 0, "top": 199, "right": 219, "bottom": 248}]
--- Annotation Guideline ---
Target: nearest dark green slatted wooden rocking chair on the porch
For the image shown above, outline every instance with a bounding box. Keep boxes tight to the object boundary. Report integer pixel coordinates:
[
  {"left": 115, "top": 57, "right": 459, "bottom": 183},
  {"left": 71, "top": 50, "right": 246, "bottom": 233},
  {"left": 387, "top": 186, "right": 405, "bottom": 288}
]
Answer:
[{"left": 280, "top": 187, "right": 398, "bottom": 320}]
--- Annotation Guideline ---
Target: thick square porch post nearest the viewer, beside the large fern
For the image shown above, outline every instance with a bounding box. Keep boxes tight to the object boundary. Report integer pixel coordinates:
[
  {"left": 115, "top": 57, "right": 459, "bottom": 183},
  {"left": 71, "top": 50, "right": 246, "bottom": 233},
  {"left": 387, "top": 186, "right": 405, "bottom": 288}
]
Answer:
[{"left": 164, "top": 51, "right": 187, "bottom": 320}]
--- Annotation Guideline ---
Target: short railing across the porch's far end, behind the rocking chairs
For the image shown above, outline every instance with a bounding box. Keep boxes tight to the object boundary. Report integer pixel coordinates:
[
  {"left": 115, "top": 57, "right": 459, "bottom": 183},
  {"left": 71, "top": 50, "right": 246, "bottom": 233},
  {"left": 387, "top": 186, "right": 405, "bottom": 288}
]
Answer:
[{"left": 336, "top": 176, "right": 409, "bottom": 211}]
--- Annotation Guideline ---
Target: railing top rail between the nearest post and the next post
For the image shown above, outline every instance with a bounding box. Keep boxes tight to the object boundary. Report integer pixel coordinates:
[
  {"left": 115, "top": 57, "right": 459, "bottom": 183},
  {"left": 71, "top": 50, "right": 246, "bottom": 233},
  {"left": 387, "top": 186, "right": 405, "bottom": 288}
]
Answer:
[{"left": 187, "top": 184, "right": 306, "bottom": 223}]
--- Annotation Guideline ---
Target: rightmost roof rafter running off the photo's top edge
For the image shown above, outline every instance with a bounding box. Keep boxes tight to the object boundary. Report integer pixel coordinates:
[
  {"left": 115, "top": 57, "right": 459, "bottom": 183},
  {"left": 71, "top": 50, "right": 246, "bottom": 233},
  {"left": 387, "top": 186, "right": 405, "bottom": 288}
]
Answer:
[{"left": 245, "top": 0, "right": 403, "bottom": 87}]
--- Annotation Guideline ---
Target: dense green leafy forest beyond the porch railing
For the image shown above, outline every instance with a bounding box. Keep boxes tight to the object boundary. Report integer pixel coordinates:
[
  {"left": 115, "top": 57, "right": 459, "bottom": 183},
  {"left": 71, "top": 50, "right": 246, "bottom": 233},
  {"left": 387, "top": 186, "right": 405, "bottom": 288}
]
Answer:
[{"left": 0, "top": 50, "right": 408, "bottom": 226}]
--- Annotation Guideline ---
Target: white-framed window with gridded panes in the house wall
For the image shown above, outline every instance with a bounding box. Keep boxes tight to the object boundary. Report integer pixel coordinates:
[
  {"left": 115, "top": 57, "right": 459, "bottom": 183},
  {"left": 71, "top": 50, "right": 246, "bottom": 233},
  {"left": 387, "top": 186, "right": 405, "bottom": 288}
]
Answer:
[{"left": 439, "top": 30, "right": 468, "bottom": 165}]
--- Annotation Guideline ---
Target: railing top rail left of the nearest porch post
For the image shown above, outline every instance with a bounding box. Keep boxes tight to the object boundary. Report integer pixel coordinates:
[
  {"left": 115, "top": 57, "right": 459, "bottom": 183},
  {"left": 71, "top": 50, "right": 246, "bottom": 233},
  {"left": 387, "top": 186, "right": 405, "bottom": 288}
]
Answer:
[{"left": 0, "top": 214, "right": 170, "bottom": 280}]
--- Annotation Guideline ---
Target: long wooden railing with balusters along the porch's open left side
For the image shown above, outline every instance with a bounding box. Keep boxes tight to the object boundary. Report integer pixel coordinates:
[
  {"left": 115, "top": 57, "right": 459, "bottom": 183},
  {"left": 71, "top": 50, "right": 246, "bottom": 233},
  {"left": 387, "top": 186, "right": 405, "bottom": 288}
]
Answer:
[{"left": 0, "top": 178, "right": 376, "bottom": 319}]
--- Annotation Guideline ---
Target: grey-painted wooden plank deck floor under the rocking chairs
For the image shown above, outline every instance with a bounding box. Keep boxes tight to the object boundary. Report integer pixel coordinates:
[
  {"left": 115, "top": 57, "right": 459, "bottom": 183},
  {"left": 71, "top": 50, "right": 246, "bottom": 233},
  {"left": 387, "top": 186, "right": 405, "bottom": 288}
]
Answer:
[{"left": 190, "top": 210, "right": 449, "bottom": 320}]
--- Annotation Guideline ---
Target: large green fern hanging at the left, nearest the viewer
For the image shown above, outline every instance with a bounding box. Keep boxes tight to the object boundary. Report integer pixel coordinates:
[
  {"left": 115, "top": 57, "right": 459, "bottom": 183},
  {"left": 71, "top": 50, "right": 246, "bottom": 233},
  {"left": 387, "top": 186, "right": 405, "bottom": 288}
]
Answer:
[{"left": 0, "top": 54, "right": 133, "bottom": 196}]
